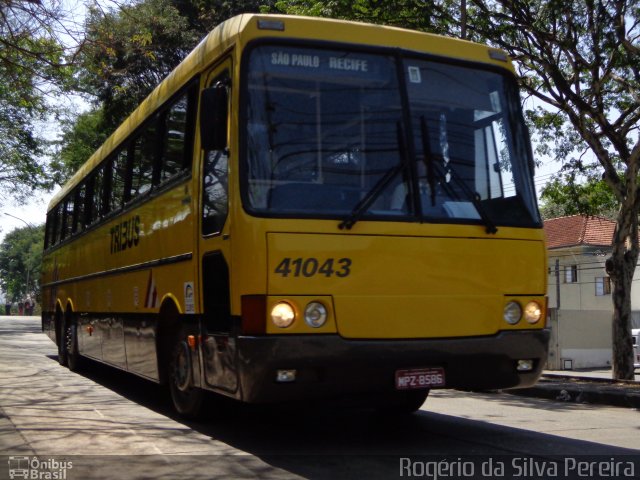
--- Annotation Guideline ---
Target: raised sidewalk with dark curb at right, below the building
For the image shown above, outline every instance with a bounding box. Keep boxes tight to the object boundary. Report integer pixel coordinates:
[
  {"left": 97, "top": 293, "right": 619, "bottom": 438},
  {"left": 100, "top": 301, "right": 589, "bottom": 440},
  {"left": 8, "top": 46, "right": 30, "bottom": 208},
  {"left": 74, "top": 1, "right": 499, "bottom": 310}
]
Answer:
[{"left": 509, "top": 369, "right": 640, "bottom": 409}]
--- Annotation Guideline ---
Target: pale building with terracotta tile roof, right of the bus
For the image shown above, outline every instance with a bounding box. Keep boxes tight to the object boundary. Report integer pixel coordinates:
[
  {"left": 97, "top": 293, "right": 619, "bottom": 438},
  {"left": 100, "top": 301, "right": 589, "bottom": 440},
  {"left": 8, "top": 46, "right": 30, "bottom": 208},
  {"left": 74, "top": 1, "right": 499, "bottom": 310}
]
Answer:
[{"left": 544, "top": 215, "right": 640, "bottom": 370}]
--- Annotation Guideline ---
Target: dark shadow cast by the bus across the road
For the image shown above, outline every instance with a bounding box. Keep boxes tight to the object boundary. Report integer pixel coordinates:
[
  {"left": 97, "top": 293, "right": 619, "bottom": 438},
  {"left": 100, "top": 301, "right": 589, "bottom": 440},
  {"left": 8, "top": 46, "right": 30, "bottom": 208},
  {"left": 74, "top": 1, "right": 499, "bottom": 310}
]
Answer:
[{"left": 61, "top": 357, "right": 638, "bottom": 463}]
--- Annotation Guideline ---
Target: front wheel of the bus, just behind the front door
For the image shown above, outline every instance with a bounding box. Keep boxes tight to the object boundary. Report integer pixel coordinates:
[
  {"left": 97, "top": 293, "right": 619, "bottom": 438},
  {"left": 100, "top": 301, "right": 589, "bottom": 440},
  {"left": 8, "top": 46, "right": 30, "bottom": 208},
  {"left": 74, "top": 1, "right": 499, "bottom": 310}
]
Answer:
[{"left": 167, "top": 335, "right": 205, "bottom": 418}]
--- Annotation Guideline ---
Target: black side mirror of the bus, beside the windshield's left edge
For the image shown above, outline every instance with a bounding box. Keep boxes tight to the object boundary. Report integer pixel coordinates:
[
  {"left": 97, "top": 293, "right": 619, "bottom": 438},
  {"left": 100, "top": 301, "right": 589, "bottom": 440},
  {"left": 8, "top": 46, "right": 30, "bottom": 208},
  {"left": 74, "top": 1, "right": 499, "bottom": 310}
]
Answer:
[{"left": 200, "top": 83, "right": 229, "bottom": 151}]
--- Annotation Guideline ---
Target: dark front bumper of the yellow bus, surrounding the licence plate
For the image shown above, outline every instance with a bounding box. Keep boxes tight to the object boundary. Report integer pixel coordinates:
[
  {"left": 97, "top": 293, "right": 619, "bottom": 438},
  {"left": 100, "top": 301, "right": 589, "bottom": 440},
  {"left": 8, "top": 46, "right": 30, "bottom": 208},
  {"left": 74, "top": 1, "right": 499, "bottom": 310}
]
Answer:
[{"left": 237, "top": 330, "right": 549, "bottom": 403}]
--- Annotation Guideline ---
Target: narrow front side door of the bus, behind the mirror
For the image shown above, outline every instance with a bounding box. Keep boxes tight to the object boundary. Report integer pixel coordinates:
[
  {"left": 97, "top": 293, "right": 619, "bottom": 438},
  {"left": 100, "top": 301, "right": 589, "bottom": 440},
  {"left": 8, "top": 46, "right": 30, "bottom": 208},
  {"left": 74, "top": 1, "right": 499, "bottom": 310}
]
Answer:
[{"left": 198, "top": 60, "right": 238, "bottom": 392}]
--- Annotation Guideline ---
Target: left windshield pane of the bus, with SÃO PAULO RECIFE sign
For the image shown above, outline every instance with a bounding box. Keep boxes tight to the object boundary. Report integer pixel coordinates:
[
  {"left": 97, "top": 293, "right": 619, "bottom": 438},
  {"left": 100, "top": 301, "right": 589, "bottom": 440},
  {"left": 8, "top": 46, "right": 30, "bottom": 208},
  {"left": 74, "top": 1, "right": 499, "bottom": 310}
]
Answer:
[{"left": 245, "top": 47, "right": 402, "bottom": 215}]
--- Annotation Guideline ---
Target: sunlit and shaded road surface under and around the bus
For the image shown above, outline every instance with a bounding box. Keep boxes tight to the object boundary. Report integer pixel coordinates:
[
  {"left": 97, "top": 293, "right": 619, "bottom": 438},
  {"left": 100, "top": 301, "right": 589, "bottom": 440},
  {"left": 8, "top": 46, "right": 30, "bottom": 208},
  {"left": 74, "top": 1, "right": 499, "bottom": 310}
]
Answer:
[{"left": 0, "top": 317, "right": 640, "bottom": 480}]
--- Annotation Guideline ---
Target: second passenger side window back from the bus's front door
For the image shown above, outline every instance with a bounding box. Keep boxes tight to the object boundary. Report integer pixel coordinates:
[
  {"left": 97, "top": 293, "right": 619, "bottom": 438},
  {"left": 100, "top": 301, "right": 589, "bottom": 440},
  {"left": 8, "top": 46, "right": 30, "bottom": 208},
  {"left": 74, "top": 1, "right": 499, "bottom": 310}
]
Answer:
[{"left": 129, "top": 121, "right": 158, "bottom": 199}]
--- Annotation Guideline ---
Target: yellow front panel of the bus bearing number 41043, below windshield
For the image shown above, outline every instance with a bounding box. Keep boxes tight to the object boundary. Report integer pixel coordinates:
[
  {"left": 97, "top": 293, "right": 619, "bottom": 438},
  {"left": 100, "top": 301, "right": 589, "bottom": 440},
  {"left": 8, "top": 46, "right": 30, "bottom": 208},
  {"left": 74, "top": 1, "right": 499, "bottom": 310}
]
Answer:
[{"left": 267, "top": 225, "right": 545, "bottom": 338}]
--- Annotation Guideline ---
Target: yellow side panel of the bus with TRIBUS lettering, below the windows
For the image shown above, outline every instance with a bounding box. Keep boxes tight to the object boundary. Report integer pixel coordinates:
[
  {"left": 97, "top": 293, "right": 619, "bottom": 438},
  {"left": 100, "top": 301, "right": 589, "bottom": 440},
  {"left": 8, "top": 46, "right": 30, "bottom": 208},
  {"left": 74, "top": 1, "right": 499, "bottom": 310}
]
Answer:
[{"left": 42, "top": 181, "right": 197, "bottom": 313}]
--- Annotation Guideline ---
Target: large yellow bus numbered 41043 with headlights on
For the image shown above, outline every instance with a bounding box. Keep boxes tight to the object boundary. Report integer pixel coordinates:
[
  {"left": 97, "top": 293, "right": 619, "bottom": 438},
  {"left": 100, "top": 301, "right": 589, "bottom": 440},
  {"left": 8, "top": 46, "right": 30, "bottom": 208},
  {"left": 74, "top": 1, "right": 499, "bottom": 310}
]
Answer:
[{"left": 42, "top": 15, "right": 549, "bottom": 415}]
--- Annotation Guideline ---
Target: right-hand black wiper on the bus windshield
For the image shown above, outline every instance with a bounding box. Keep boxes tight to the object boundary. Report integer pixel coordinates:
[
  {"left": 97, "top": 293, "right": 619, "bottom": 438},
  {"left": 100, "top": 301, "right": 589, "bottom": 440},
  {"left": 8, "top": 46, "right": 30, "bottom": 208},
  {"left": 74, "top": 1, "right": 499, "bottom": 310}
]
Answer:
[{"left": 420, "top": 116, "right": 498, "bottom": 234}]
